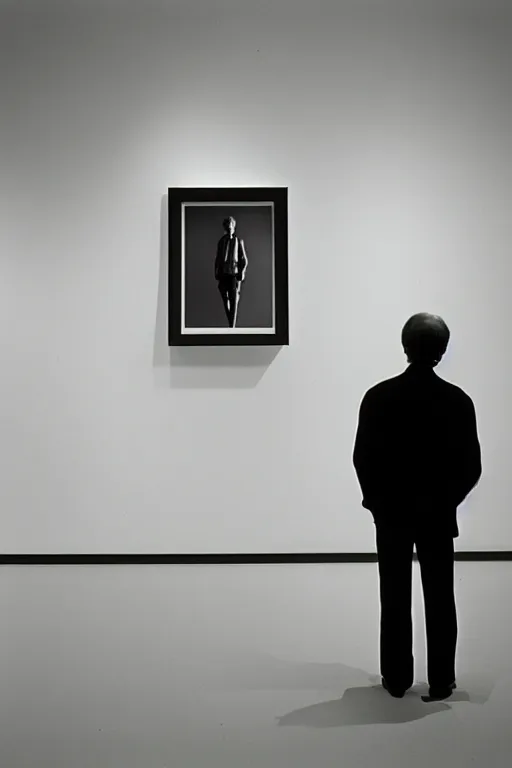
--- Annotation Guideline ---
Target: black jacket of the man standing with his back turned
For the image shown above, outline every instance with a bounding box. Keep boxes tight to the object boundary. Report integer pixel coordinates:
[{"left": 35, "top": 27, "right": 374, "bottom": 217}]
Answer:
[{"left": 353, "top": 364, "right": 482, "bottom": 538}]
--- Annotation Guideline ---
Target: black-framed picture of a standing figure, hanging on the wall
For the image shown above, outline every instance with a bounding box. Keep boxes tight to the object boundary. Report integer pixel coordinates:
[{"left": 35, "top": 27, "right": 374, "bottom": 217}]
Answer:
[{"left": 169, "top": 187, "right": 288, "bottom": 346}]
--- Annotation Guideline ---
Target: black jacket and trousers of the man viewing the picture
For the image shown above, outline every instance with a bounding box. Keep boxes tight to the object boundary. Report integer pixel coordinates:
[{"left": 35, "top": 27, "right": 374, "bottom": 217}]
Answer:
[{"left": 353, "top": 363, "right": 482, "bottom": 690}]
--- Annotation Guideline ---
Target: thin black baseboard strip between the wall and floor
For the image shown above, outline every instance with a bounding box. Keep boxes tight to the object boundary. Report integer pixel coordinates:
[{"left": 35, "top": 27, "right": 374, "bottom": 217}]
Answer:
[{"left": 0, "top": 550, "right": 512, "bottom": 565}]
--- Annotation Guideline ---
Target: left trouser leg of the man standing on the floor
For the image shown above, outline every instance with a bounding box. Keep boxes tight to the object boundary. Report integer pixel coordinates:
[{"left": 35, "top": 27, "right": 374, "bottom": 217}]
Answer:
[{"left": 376, "top": 524, "right": 414, "bottom": 690}]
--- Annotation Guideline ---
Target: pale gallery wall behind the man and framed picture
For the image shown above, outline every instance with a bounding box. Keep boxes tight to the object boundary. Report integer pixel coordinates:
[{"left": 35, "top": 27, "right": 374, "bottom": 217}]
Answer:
[{"left": 0, "top": 0, "right": 512, "bottom": 553}]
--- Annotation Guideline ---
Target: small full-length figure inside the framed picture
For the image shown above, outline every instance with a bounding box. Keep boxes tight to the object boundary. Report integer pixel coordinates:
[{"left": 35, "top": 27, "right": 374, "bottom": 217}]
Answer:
[{"left": 215, "top": 216, "right": 249, "bottom": 328}]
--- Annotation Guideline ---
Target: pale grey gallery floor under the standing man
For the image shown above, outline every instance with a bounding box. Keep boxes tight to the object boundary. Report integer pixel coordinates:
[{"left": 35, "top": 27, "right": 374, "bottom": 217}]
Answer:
[{"left": 0, "top": 562, "right": 512, "bottom": 768}]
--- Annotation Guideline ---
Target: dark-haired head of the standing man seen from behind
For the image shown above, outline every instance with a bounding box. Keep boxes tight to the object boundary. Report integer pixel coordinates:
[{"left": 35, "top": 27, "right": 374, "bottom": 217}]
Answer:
[{"left": 402, "top": 312, "right": 450, "bottom": 367}]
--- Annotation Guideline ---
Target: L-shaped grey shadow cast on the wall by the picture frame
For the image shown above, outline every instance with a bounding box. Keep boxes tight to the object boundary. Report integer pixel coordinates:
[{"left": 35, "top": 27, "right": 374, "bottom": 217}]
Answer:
[{"left": 153, "top": 194, "right": 282, "bottom": 389}]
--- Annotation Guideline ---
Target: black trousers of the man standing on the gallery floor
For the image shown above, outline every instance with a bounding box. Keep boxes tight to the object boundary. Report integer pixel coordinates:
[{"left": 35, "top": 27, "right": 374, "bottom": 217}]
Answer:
[{"left": 376, "top": 523, "right": 457, "bottom": 690}]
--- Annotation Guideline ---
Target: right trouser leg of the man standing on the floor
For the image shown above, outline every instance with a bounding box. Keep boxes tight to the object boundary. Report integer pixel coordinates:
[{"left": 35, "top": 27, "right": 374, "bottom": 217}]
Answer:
[{"left": 416, "top": 532, "right": 457, "bottom": 688}]
